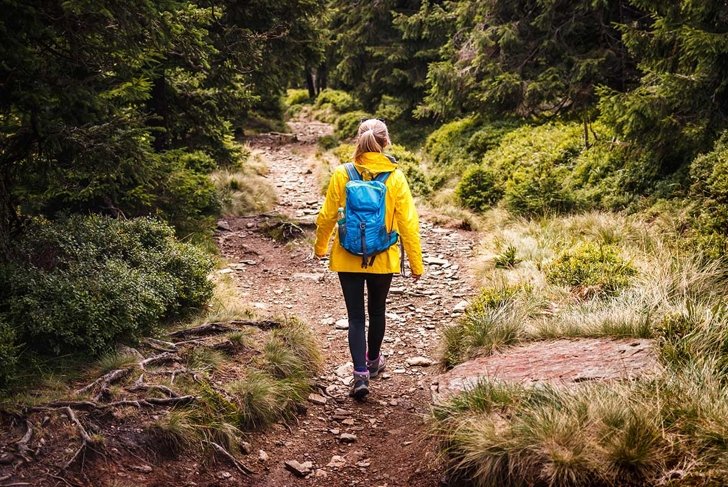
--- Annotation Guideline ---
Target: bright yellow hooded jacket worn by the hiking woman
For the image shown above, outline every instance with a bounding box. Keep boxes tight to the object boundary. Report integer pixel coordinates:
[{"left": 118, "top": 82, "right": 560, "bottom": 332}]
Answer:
[{"left": 314, "top": 152, "right": 424, "bottom": 274}]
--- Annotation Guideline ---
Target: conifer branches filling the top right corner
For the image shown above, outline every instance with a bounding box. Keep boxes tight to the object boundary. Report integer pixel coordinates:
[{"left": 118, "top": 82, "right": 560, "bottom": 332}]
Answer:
[{"left": 599, "top": 0, "right": 728, "bottom": 176}]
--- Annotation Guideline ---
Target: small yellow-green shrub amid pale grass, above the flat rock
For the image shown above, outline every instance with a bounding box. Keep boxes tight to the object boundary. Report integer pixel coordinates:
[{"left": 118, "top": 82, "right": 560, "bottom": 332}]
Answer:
[{"left": 546, "top": 242, "right": 637, "bottom": 295}]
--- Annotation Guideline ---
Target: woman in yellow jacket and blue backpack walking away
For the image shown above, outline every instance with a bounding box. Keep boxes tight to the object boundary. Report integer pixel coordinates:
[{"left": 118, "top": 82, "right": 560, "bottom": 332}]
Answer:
[{"left": 314, "top": 119, "right": 424, "bottom": 400}]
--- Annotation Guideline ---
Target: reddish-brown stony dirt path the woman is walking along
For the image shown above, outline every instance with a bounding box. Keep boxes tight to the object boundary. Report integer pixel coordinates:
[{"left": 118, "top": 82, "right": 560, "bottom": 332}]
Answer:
[{"left": 220, "top": 122, "right": 475, "bottom": 487}]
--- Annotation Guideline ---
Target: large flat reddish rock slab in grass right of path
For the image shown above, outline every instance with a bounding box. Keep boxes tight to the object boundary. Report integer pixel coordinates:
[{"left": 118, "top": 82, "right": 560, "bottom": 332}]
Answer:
[{"left": 432, "top": 338, "right": 660, "bottom": 403}]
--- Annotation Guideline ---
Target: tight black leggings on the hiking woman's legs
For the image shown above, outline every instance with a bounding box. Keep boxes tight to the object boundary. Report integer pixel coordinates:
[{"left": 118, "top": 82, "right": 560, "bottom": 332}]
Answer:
[{"left": 339, "top": 272, "right": 392, "bottom": 371}]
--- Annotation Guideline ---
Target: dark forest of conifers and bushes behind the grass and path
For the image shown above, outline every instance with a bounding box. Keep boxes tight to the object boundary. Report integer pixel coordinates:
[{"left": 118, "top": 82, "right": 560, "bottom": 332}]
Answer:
[{"left": 0, "top": 0, "right": 728, "bottom": 383}]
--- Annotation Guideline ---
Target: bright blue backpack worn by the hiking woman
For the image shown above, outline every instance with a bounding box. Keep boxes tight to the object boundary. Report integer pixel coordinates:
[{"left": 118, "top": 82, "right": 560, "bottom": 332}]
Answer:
[{"left": 339, "top": 163, "right": 399, "bottom": 269}]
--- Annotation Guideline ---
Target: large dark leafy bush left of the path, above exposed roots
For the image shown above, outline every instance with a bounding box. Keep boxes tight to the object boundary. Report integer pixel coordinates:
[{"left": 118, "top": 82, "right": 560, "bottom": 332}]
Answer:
[{"left": 4, "top": 216, "right": 212, "bottom": 354}]
